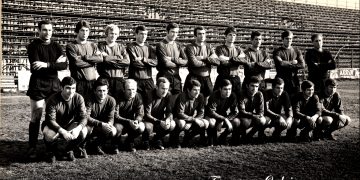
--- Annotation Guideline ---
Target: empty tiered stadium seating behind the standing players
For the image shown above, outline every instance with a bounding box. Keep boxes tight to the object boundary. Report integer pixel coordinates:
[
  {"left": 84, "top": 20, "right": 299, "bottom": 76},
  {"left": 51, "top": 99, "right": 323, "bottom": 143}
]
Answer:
[{"left": 2, "top": 0, "right": 360, "bottom": 76}]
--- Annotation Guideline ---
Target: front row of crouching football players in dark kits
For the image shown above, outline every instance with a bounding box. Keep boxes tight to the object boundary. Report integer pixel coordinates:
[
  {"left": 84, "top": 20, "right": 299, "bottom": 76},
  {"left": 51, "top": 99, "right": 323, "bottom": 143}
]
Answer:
[{"left": 42, "top": 77, "right": 350, "bottom": 161}]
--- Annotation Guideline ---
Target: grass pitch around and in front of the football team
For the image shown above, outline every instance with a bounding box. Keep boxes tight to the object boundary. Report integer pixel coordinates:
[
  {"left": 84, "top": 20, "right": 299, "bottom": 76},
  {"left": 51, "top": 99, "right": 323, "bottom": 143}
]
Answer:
[{"left": 0, "top": 80, "right": 360, "bottom": 179}]
